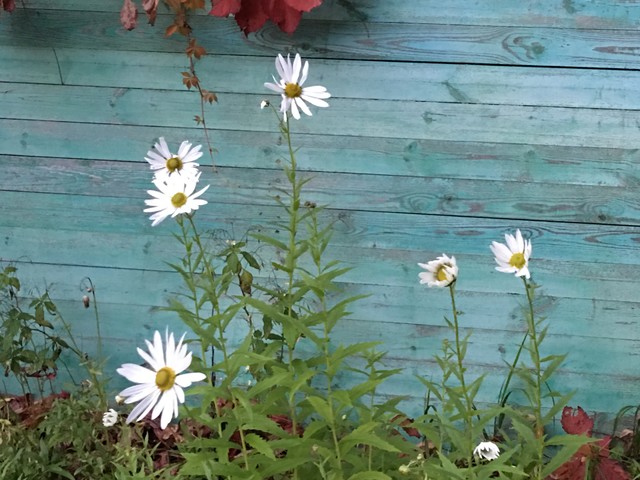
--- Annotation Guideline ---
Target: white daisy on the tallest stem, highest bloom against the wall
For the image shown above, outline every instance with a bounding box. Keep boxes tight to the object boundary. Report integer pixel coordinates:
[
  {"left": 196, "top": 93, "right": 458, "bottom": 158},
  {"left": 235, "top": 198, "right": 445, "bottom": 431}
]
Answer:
[{"left": 264, "top": 53, "right": 331, "bottom": 122}]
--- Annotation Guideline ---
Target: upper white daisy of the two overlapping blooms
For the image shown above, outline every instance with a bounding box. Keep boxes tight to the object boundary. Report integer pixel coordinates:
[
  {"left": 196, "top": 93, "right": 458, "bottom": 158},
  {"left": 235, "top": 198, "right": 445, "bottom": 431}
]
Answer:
[{"left": 144, "top": 137, "right": 202, "bottom": 180}]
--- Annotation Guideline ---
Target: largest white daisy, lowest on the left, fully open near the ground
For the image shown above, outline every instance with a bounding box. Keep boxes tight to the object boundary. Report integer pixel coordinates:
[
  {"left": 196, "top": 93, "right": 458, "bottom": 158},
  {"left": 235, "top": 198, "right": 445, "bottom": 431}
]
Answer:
[{"left": 116, "top": 330, "right": 206, "bottom": 429}]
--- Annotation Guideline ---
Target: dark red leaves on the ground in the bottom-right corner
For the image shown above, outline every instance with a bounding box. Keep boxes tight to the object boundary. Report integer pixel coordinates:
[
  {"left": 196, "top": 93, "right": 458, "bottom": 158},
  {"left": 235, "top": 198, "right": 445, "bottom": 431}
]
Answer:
[{"left": 549, "top": 407, "right": 631, "bottom": 480}]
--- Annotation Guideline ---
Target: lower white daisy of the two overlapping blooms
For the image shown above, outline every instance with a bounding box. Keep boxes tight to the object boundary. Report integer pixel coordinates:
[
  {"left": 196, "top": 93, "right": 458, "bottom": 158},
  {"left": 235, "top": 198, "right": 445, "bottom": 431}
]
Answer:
[{"left": 144, "top": 173, "right": 209, "bottom": 227}]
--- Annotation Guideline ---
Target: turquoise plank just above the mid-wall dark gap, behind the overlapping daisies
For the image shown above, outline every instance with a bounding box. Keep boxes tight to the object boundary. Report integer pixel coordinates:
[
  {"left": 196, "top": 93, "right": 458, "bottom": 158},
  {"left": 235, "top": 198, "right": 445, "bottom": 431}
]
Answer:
[{"left": 5, "top": 157, "right": 640, "bottom": 225}]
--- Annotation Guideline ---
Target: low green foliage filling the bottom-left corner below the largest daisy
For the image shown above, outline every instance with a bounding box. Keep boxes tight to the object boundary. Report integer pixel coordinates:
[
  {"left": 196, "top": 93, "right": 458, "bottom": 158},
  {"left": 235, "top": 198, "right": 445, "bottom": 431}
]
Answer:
[{"left": 0, "top": 389, "right": 169, "bottom": 480}]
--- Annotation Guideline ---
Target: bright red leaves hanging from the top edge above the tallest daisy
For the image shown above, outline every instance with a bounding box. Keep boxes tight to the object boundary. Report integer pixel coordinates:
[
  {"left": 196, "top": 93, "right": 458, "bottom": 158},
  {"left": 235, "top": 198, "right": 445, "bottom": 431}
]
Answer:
[{"left": 209, "top": 0, "right": 322, "bottom": 35}]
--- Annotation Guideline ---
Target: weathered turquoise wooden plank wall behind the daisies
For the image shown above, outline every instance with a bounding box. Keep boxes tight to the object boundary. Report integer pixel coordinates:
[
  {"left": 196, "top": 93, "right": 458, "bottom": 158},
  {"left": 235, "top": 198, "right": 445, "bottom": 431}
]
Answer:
[{"left": 0, "top": 0, "right": 640, "bottom": 420}]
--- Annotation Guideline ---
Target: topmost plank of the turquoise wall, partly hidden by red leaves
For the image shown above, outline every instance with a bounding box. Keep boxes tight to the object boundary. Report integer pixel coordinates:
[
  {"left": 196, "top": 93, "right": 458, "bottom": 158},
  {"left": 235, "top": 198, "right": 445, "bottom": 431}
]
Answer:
[{"left": 16, "top": 0, "right": 640, "bottom": 29}]
